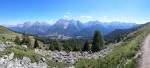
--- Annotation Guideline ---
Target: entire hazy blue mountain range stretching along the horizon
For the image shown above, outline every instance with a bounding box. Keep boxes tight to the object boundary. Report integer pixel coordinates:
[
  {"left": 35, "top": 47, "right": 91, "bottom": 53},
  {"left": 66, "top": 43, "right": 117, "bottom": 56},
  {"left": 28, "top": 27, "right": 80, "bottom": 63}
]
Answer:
[{"left": 8, "top": 19, "right": 137, "bottom": 37}]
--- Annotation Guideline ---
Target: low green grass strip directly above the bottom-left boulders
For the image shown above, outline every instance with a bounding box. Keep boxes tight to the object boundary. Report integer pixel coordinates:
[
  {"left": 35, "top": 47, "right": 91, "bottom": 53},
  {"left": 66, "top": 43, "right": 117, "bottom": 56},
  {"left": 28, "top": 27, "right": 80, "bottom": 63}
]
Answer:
[{"left": 0, "top": 47, "right": 42, "bottom": 62}]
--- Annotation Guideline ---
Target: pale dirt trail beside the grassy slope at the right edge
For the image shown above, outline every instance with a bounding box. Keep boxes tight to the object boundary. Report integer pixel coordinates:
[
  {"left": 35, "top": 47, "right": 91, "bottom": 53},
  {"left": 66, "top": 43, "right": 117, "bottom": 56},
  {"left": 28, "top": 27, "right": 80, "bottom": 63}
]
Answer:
[{"left": 139, "top": 34, "right": 150, "bottom": 68}]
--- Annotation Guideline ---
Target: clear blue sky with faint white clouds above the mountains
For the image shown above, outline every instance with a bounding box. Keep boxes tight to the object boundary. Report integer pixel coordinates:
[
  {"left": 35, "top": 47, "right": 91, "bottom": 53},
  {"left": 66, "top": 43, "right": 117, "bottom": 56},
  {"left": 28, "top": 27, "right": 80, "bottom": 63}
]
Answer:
[{"left": 0, "top": 0, "right": 150, "bottom": 25}]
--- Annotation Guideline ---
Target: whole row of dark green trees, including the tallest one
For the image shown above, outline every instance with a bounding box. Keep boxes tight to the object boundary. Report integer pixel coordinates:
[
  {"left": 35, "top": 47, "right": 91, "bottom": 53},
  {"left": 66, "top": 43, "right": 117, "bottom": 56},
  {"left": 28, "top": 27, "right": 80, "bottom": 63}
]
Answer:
[{"left": 14, "top": 30, "right": 104, "bottom": 52}]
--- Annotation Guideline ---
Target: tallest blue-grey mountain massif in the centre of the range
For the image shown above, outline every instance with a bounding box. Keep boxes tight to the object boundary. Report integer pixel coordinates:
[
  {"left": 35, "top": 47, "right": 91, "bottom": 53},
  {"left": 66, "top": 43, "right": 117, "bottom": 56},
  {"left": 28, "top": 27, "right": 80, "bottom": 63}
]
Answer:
[{"left": 49, "top": 19, "right": 84, "bottom": 35}]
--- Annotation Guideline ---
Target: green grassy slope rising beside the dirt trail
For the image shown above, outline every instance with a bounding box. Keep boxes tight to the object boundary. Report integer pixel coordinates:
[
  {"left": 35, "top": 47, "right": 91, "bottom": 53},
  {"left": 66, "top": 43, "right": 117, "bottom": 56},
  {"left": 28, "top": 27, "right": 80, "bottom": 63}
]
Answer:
[{"left": 75, "top": 23, "right": 150, "bottom": 68}]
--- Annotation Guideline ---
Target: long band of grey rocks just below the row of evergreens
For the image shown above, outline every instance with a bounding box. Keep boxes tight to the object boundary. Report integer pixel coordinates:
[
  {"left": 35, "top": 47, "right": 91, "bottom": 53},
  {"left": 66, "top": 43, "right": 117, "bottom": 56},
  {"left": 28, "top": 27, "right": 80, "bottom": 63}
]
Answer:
[{"left": 35, "top": 46, "right": 112, "bottom": 64}]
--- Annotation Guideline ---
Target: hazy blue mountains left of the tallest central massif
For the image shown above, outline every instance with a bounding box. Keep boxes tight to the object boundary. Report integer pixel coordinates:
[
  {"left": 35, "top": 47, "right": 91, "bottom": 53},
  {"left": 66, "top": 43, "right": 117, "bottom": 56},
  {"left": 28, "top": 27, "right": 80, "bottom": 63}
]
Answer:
[{"left": 9, "top": 21, "right": 51, "bottom": 35}]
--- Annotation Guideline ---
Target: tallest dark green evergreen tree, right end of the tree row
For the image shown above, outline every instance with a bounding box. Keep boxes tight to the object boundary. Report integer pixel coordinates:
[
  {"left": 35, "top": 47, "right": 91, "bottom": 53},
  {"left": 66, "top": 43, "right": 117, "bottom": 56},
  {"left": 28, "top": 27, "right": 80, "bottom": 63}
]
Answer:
[{"left": 92, "top": 30, "right": 104, "bottom": 52}]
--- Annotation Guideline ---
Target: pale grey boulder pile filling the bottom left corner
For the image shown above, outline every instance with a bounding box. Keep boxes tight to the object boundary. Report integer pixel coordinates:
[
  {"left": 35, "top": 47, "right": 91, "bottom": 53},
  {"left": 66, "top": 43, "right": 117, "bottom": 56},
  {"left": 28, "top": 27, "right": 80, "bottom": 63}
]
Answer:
[{"left": 0, "top": 53, "right": 48, "bottom": 68}]
